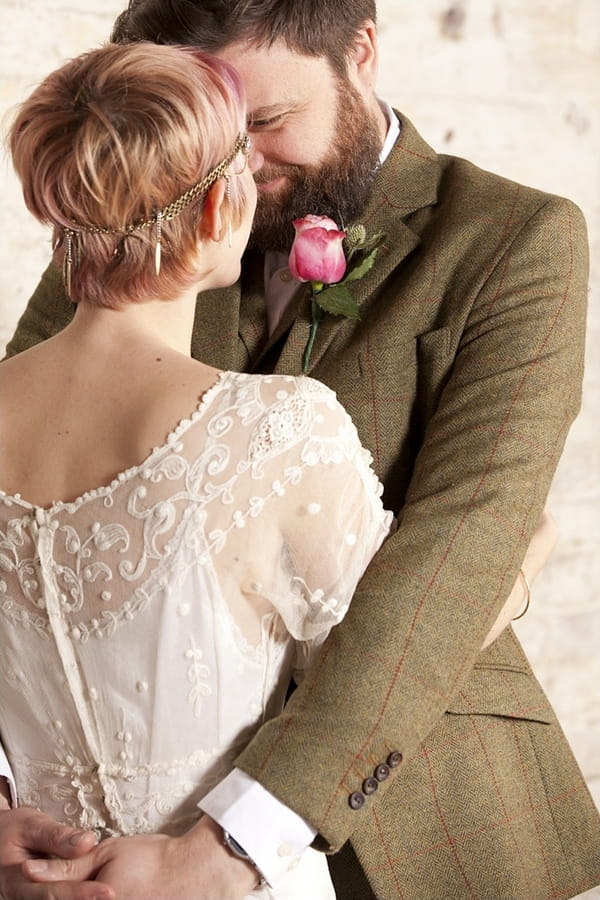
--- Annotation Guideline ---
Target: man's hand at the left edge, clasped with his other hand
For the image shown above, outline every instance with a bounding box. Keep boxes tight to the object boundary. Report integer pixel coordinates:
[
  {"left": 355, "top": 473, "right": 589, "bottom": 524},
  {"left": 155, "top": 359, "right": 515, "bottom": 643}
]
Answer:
[{"left": 0, "top": 803, "right": 115, "bottom": 900}]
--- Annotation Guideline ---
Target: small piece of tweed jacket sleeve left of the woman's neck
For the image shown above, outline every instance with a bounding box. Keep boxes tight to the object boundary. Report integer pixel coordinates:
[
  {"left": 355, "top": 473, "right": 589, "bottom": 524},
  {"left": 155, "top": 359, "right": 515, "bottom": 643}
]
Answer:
[{"left": 6, "top": 263, "right": 75, "bottom": 357}]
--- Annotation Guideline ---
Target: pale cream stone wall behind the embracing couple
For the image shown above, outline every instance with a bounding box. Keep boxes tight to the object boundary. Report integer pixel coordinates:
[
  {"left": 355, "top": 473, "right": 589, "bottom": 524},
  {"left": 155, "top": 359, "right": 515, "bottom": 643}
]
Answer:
[{"left": 0, "top": 0, "right": 600, "bottom": 900}]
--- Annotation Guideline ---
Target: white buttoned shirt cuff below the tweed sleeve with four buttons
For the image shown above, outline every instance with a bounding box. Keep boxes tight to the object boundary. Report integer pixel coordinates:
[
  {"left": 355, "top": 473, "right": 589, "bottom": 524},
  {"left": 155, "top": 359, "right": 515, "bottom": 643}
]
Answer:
[{"left": 198, "top": 769, "right": 317, "bottom": 887}]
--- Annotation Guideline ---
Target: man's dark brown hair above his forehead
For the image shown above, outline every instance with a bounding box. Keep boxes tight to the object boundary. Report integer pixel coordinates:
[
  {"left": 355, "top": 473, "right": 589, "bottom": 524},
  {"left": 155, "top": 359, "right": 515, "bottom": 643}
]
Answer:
[{"left": 111, "top": 0, "right": 376, "bottom": 77}]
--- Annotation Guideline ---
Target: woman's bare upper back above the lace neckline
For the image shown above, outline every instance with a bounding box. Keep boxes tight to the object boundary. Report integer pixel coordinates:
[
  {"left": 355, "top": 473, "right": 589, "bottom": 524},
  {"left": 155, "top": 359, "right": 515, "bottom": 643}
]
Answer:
[{"left": 0, "top": 326, "right": 217, "bottom": 507}]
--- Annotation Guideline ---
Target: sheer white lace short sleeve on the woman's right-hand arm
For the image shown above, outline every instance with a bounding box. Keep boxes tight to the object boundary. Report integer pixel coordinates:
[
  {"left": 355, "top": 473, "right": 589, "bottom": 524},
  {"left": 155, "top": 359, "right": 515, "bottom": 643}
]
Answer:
[{"left": 258, "top": 379, "right": 393, "bottom": 668}]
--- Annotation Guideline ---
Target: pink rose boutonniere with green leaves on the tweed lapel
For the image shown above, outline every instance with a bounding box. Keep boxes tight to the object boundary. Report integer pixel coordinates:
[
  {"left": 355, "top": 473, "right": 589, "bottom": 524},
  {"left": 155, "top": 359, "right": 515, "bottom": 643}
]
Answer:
[{"left": 289, "top": 215, "right": 385, "bottom": 372}]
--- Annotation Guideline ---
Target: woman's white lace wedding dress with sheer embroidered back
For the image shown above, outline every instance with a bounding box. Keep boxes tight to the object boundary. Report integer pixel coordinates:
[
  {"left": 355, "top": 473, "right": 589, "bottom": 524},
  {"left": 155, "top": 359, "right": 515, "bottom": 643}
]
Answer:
[{"left": 0, "top": 372, "right": 391, "bottom": 900}]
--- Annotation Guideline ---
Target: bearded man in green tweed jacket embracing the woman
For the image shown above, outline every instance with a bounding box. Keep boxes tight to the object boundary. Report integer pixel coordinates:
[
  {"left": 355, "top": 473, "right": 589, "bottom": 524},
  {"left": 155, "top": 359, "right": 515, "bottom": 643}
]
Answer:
[{"left": 1, "top": 0, "right": 600, "bottom": 900}]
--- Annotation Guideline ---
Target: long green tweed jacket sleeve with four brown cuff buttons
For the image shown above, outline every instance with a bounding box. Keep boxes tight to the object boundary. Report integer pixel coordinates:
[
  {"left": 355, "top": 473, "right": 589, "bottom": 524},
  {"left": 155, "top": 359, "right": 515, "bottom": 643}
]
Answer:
[{"left": 236, "top": 198, "right": 588, "bottom": 851}]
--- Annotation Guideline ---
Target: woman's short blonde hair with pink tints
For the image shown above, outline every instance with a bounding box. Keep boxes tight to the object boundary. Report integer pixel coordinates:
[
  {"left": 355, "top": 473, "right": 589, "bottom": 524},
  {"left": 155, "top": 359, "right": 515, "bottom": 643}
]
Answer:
[{"left": 9, "top": 42, "right": 245, "bottom": 307}]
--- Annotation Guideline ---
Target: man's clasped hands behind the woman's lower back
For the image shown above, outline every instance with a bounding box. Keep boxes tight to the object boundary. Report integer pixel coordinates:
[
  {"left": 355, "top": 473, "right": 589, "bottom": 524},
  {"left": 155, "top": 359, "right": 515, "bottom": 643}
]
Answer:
[{"left": 0, "top": 807, "right": 257, "bottom": 900}]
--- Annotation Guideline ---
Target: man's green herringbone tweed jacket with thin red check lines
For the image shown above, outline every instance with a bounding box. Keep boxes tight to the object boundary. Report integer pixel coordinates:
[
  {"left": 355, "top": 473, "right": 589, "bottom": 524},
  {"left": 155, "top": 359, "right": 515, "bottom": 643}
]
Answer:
[{"left": 9, "top": 119, "right": 600, "bottom": 900}]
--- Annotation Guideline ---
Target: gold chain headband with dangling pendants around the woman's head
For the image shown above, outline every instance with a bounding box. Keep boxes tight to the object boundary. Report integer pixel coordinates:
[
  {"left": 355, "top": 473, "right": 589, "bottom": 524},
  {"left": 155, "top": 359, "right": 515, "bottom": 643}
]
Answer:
[{"left": 63, "top": 134, "right": 251, "bottom": 296}]
